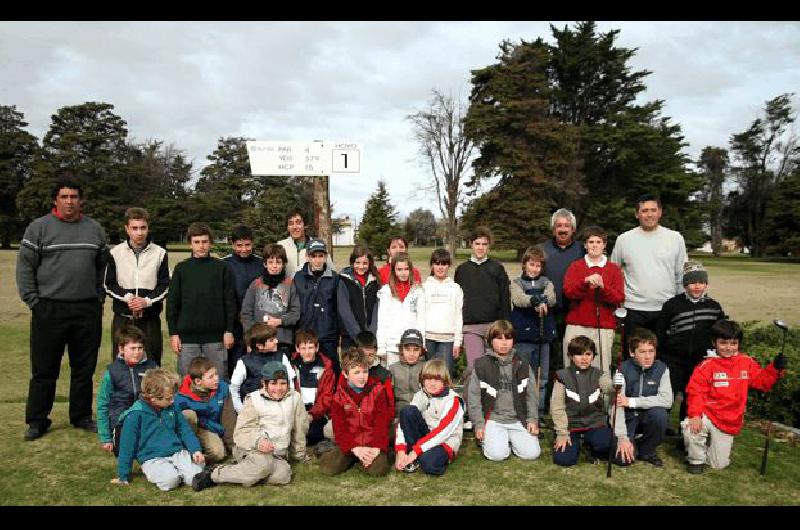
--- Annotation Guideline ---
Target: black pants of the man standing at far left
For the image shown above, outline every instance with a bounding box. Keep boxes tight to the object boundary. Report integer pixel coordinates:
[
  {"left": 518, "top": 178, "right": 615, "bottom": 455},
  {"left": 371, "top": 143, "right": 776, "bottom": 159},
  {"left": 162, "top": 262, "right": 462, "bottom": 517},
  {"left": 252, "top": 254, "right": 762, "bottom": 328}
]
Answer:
[{"left": 25, "top": 300, "right": 103, "bottom": 428}]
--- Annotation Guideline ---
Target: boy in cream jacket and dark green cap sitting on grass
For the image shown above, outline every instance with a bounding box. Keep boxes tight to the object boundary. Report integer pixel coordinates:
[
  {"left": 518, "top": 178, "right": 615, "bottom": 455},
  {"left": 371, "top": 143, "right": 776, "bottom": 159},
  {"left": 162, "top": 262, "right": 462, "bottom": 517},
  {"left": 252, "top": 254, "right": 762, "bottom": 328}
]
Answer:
[{"left": 192, "top": 361, "right": 308, "bottom": 491}]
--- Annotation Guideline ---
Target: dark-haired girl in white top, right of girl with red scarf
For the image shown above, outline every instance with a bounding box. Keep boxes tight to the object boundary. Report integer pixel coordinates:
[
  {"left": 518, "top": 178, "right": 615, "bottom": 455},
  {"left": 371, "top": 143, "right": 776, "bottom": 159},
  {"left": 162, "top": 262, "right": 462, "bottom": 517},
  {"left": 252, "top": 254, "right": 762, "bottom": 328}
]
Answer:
[{"left": 422, "top": 248, "right": 464, "bottom": 378}]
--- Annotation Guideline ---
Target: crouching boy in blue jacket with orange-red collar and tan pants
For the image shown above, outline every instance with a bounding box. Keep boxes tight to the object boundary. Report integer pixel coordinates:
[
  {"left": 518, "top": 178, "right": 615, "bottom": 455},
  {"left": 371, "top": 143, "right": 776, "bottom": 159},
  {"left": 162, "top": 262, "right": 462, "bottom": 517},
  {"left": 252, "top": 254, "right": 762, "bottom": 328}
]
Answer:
[{"left": 175, "top": 357, "right": 235, "bottom": 463}]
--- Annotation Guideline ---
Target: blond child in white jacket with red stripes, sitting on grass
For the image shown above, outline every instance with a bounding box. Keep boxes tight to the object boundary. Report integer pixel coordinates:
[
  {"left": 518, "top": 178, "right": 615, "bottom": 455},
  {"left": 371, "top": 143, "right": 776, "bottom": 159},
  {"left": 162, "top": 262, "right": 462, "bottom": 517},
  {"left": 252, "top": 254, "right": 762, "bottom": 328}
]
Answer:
[{"left": 395, "top": 359, "right": 464, "bottom": 475}]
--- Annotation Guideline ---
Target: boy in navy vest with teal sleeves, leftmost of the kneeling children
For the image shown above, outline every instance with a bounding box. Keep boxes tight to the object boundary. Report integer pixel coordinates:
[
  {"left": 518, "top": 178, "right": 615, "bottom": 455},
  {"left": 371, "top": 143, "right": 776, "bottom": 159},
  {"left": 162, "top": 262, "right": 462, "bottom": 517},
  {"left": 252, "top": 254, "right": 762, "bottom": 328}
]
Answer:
[{"left": 97, "top": 326, "right": 158, "bottom": 456}]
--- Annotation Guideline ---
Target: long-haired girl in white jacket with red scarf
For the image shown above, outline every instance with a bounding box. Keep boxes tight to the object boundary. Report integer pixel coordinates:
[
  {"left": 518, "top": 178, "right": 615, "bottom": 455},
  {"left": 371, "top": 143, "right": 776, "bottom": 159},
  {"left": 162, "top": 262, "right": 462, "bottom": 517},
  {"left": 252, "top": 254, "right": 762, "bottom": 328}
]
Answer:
[{"left": 375, "top": 252, "right": 425, "bottom": 367}]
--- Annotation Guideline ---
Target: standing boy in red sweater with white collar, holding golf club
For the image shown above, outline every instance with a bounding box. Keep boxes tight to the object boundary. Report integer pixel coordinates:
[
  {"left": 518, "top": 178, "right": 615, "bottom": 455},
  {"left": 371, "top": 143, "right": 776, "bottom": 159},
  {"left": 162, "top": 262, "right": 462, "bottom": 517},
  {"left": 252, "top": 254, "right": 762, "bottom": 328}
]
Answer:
[{"left": 563, "top": 226, "right": 625, "bottom": 372}]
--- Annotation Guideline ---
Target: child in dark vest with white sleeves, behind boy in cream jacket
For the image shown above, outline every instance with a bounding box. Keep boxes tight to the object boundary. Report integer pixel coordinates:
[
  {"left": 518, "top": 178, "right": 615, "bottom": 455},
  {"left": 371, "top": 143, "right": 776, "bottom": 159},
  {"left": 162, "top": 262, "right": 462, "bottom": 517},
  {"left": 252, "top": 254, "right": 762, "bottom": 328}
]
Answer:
[{"left": 231, "top": 322, "right": 297, "bottom": 413}]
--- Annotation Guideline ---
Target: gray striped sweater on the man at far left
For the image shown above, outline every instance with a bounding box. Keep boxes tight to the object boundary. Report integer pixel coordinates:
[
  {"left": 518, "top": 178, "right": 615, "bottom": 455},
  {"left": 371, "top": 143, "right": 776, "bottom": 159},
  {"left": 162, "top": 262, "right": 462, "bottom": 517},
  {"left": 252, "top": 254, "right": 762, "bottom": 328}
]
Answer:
[{"left": 17, "top": 213, "right": 108, "bottom": 309}]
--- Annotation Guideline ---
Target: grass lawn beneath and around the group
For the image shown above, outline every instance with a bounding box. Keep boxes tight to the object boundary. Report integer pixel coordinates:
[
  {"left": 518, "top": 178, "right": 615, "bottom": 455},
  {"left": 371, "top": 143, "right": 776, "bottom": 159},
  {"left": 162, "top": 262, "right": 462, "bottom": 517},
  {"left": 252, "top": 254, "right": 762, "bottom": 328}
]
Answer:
[{"left": 0, "top": 248, "right": 800, "bottom": 506}]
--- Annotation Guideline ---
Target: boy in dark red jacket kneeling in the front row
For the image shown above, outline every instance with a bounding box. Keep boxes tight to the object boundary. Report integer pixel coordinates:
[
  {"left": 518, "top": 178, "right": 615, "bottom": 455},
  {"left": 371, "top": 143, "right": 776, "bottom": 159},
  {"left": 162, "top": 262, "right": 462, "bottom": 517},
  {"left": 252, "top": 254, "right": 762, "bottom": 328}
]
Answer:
[{"left": 320, "top": 348, "right": 390, "bottom": 477}]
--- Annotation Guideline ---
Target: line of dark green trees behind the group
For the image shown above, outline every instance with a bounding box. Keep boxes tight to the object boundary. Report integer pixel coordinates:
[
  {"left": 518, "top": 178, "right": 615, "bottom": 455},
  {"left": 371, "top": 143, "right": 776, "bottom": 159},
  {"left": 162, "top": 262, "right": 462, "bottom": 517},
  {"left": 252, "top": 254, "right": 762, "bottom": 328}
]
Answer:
[{"left": 0, "top": 22, "right": 800, "bottom": 256}]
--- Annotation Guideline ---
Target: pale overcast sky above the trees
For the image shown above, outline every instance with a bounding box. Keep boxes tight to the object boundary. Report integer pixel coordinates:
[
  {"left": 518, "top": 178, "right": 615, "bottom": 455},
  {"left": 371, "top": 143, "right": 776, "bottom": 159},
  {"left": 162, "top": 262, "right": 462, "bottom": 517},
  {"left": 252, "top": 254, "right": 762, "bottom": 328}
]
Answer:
[{"left": 0, "top": 21, "right": 800, "bottom": 220}]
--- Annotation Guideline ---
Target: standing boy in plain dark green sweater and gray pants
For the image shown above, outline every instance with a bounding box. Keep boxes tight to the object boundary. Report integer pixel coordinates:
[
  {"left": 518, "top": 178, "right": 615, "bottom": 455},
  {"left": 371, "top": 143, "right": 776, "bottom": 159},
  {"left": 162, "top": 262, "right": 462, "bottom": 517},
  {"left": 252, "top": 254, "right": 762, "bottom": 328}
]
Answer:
[{"left": 167, "top": 223, "right": 236, "bottom": 377}]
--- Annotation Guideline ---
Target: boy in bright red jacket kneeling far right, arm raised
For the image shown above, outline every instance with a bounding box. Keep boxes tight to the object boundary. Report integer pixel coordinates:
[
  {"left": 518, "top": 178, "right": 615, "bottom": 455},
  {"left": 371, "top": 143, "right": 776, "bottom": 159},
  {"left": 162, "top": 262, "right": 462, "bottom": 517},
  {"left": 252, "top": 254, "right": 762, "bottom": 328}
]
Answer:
[{"left": 681, "top": 320, "right": 786, "bottom": 474}]
